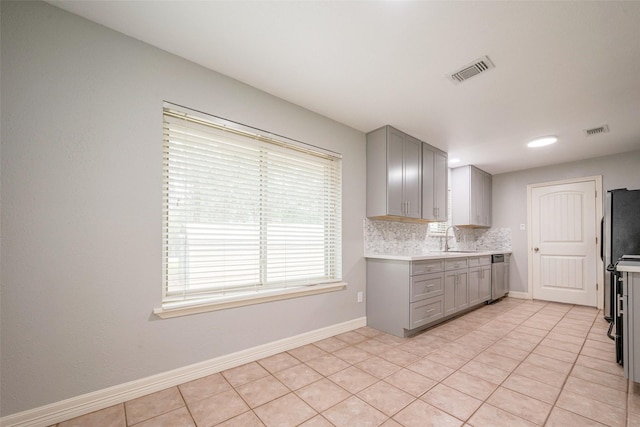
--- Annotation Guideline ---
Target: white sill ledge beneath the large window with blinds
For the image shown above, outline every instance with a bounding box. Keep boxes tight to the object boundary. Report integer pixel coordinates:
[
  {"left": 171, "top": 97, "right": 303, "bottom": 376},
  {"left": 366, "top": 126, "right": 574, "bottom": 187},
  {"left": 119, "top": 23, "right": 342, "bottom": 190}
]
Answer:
[{"left": 153, "top": 282, "right": 347, "bottom": 319}]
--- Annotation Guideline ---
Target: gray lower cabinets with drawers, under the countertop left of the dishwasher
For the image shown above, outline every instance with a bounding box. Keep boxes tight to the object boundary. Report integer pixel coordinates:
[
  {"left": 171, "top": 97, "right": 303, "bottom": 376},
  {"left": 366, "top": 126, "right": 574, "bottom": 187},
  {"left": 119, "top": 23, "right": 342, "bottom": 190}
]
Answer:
[{"left": 367, "top": 255, "right": 491, "bottom": 337}]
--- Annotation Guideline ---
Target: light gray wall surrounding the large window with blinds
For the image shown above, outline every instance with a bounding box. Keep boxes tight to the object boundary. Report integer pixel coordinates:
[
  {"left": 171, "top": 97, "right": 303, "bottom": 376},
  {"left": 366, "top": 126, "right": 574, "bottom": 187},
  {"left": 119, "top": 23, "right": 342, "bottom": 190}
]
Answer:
[{"left": 0, "top": 1, "right": 366, "bottom": 416}]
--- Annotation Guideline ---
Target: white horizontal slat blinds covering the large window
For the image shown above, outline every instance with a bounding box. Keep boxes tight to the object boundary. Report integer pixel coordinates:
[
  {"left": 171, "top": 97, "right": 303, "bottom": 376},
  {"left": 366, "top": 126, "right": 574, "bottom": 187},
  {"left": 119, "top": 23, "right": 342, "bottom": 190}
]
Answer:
[{"left": 162, "top": 105, "right": 342, "bottom": 307}]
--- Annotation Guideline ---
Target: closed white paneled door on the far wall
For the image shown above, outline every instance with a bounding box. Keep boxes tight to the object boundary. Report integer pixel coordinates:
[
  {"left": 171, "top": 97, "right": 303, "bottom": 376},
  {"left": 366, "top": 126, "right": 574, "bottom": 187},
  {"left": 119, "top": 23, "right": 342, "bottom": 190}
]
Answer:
[{"left": 530, "top": 181, "right": 599, "bottom": 307}]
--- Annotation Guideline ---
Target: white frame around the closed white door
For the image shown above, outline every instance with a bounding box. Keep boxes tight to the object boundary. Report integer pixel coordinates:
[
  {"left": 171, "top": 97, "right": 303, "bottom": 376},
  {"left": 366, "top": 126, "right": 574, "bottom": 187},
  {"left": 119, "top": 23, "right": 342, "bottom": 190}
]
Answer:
[{"left": 526, "top": 175, "right": 604, "bottom": 310}]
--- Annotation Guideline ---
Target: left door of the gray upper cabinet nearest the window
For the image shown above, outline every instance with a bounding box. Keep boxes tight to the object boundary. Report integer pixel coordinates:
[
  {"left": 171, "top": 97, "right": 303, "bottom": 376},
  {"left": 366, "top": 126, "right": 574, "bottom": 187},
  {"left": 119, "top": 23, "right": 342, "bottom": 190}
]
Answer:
[{"left": 387, "top": 129, "right": 405, "bottom": 216}]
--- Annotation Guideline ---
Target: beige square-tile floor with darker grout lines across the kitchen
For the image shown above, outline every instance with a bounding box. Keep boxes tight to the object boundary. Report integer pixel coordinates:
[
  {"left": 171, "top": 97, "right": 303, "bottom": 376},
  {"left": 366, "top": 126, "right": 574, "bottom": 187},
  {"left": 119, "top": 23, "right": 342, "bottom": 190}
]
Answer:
[{"left": 58, "top": 298, "right": 640, "bottom": 427}]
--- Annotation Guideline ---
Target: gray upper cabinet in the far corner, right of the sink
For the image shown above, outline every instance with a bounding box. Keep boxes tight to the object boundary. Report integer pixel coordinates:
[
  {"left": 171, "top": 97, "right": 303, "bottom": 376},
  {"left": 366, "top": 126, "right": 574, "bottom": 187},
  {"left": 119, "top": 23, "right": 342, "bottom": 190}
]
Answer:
[{"left": 451, "top": 165, "right": 492, "bottom": 227}]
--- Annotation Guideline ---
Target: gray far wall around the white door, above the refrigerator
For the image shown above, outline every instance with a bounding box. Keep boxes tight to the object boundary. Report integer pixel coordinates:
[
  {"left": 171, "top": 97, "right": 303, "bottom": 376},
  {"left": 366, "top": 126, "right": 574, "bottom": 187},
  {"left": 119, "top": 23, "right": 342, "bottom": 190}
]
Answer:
[{"left": 492, "top": 150, "right": 640, "bottom": 292}]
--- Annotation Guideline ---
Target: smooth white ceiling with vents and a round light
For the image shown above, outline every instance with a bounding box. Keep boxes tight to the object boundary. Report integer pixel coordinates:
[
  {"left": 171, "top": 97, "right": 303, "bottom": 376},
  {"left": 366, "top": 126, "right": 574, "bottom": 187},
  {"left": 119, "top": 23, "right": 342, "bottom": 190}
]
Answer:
[{"left": 50, "top": 0, "right": 640, "bottom": 174}]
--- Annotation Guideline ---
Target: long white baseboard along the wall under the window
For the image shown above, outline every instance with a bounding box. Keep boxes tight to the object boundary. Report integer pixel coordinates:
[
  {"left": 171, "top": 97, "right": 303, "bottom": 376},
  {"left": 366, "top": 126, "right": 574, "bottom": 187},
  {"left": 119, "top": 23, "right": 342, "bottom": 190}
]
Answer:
[{"left": 0, "top": 317, "right": 367, "bottom": 427}]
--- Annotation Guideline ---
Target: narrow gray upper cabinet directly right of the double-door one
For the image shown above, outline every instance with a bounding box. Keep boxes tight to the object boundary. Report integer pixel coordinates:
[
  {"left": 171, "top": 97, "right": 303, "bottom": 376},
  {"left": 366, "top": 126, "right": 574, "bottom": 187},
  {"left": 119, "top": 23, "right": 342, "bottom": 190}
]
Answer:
[{"left": 422, "top": 143, "right": 449, "bottom": 222}]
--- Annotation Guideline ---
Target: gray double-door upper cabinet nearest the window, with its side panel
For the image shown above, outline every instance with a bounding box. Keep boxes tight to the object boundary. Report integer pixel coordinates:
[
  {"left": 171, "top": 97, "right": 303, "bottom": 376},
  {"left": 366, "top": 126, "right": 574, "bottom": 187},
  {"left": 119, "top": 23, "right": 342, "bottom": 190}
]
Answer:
[{"left": 367, "top": 126, "right": 422, "bottom": 219}]
